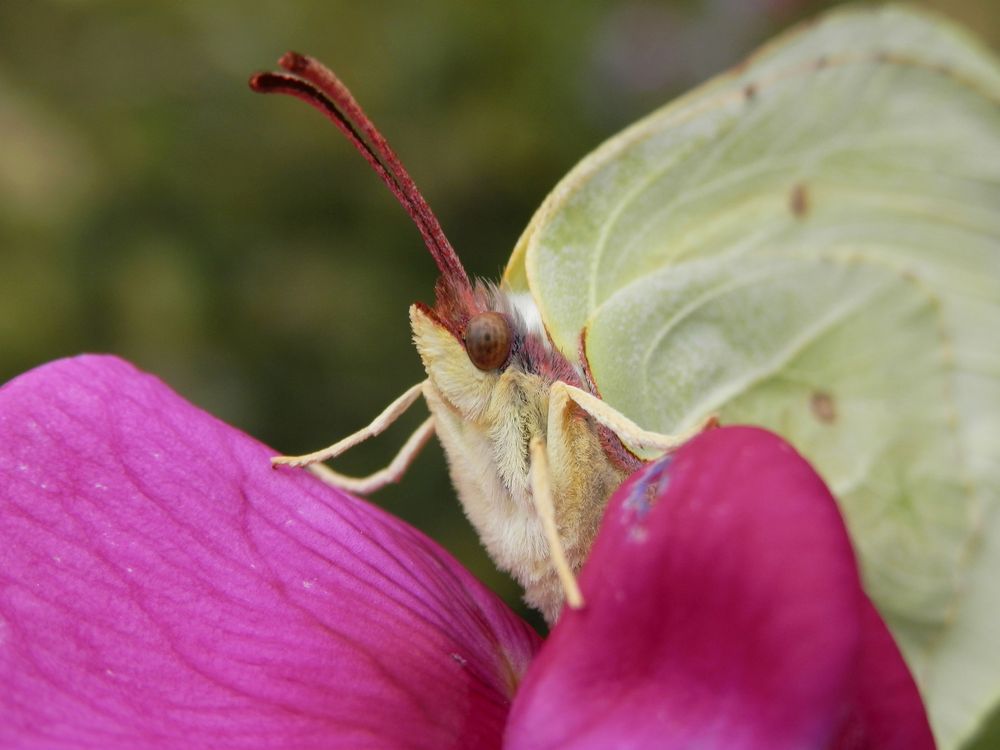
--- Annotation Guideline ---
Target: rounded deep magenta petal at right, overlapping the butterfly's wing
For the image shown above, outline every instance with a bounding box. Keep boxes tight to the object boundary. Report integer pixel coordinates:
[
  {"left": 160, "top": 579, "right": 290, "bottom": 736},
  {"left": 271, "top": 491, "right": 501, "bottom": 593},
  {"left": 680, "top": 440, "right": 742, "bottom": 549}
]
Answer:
[{"left": 505, "top": 428, "right": 933, "bottom": 750}]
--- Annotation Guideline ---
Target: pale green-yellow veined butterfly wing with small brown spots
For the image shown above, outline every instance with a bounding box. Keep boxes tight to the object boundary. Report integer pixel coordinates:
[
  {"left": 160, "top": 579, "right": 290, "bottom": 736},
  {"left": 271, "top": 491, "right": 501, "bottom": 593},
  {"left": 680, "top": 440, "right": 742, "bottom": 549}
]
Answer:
[{"left": 506, "top": 7, "right": 1000, "bottom": 747}]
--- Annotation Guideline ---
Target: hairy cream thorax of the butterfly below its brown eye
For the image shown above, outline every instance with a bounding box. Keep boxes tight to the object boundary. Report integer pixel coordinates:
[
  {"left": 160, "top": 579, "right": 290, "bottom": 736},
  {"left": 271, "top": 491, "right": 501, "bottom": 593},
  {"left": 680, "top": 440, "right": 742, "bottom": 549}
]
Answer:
[{"left": 425, "top": 371, "right": 624, "bottom": 622}]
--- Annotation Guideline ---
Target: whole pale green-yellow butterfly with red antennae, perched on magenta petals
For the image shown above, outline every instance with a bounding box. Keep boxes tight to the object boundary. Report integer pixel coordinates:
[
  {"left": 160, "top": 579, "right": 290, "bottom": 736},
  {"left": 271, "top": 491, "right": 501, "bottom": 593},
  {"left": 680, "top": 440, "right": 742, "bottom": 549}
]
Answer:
[{"left": 251, "top": 7, "right": 1000, "bottom": 739}]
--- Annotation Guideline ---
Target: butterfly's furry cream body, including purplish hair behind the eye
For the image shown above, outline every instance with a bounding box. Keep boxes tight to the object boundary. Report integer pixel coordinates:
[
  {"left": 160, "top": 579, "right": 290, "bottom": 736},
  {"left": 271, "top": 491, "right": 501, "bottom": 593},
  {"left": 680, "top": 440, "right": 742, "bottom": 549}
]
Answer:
[{"left": 410, "top": 298, "right": 639, "bottom": 621}]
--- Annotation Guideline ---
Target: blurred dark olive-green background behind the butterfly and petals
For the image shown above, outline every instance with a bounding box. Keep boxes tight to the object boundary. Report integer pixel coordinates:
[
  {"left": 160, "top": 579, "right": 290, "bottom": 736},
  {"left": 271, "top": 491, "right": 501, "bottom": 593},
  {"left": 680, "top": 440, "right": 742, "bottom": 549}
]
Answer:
[{"left": 0, "top": 0, "right": 1000, "bottom": 623}]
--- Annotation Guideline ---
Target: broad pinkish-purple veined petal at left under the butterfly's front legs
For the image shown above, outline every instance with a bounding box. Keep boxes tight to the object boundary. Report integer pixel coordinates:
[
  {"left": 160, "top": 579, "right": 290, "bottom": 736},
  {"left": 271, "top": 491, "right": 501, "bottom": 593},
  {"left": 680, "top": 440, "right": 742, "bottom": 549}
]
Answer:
[{"left": 0, "top": 357, "right": 538, "bottom": 750}]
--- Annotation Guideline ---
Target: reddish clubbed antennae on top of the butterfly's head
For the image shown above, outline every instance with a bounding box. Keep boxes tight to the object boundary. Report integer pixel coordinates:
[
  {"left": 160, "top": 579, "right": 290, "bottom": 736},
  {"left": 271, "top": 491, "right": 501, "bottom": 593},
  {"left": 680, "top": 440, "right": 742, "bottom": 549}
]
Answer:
[{"left": 250, "top": 52, "right": 472, "bottom": 324}]
